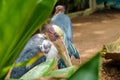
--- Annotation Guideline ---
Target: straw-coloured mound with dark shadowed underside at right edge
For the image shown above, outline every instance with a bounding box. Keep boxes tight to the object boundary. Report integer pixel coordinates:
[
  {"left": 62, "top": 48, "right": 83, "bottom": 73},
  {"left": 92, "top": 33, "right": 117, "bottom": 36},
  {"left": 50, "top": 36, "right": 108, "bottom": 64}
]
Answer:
[{"left": 101, "top": 38, "right": 120, "bottom": 61}]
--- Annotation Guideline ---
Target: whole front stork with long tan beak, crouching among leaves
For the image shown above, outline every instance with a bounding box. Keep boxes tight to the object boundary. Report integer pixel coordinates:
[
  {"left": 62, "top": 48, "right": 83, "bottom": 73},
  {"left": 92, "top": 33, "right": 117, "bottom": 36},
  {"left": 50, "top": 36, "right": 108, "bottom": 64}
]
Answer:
[{"left": 10, "top": 24, "right": 72, "bottom": 78}]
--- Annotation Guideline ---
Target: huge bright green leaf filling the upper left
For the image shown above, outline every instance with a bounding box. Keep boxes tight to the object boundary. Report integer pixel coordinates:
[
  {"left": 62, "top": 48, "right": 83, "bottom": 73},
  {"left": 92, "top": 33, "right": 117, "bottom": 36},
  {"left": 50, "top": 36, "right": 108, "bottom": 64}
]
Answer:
[{"left": 0, "top": 0, "right": 56, "bottom": 77}]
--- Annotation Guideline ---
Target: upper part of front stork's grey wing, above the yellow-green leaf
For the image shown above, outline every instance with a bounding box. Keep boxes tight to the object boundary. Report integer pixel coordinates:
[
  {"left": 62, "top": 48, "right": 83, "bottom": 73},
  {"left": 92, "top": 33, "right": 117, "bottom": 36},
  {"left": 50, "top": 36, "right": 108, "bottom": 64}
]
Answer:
[{"left": 16, "top": 34, "right": 45, "bottom": 63}]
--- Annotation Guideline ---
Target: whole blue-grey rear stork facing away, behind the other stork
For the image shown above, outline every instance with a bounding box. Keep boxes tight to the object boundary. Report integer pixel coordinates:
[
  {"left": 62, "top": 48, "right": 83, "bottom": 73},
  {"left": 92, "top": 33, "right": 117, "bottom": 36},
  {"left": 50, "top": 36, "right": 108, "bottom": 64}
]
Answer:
[{"left": 51, "top": 5, "right": 80, "bottom": 59}]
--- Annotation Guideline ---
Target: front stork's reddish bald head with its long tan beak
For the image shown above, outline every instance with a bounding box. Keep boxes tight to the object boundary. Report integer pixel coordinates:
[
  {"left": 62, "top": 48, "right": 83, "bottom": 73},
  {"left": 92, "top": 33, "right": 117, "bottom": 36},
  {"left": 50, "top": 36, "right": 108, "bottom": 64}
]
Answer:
[{"left": 44, "top": 24, "right": 72, "bottom": 66}]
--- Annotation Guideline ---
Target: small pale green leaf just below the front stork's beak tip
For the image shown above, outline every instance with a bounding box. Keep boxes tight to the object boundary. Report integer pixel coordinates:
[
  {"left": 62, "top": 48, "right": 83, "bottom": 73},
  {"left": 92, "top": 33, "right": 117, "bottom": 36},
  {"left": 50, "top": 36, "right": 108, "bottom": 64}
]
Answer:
[{"left": 47, "top": 66, "right": 76, "bottom": 78}]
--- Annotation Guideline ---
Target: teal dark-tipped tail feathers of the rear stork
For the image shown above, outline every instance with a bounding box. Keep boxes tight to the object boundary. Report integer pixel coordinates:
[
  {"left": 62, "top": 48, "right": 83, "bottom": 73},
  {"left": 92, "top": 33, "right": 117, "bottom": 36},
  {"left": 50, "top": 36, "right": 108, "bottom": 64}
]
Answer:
[{"left": 67, "top": 42, "right": 80, "bottom": 59}]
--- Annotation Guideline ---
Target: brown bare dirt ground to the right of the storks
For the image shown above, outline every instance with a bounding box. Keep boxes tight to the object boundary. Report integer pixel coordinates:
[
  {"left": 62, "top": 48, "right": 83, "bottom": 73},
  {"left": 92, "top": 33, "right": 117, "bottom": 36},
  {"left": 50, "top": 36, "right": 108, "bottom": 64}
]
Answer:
[{"left": 72, "top": 10, "right": 120, "bottom": 80}]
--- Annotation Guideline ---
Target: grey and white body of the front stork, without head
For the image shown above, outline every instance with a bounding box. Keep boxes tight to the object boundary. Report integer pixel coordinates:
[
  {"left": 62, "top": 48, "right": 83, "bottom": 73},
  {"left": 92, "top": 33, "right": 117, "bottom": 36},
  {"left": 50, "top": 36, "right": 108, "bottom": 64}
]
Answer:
[{"left": 11, "top": 34, "right": 58, "bottom": 78}]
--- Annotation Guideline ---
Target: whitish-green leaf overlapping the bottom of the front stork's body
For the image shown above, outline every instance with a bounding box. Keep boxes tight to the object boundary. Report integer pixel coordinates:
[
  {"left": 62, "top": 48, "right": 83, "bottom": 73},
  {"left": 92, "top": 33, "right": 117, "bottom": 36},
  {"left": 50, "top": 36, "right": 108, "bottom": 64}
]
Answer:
[{"left": 20, "top": 59, "right": 56, "bottom": 80}]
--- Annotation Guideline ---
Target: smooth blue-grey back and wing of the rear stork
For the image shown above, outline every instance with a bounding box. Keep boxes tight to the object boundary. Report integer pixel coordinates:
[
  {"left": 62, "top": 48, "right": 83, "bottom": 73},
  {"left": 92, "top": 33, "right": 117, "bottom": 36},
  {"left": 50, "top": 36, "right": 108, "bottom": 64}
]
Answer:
[{"left": 51, "top": 14, "right": 73, "bottom": 42}]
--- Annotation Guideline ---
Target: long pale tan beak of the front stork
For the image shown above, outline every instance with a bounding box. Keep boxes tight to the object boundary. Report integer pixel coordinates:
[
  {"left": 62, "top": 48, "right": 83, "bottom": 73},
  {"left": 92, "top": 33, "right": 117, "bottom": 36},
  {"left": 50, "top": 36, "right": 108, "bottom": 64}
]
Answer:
[{"left": 53, "top": 37, "right": 72, "bottom": 66}]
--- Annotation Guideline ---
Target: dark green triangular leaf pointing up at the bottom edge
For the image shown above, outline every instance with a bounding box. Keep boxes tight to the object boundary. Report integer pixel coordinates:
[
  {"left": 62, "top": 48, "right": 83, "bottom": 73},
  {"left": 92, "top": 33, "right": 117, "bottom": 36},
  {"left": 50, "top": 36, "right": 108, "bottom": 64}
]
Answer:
[{"left": 68, "top": 53, "right": 100, "bottom": 80}]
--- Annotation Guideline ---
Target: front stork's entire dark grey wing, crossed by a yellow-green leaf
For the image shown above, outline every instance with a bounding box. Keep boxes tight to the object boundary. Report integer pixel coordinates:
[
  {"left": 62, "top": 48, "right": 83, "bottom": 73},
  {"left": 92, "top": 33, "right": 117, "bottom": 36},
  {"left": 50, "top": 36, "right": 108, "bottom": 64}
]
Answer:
[{"left": 10, "top": 34, "right": 51, "bottom": 78}]
